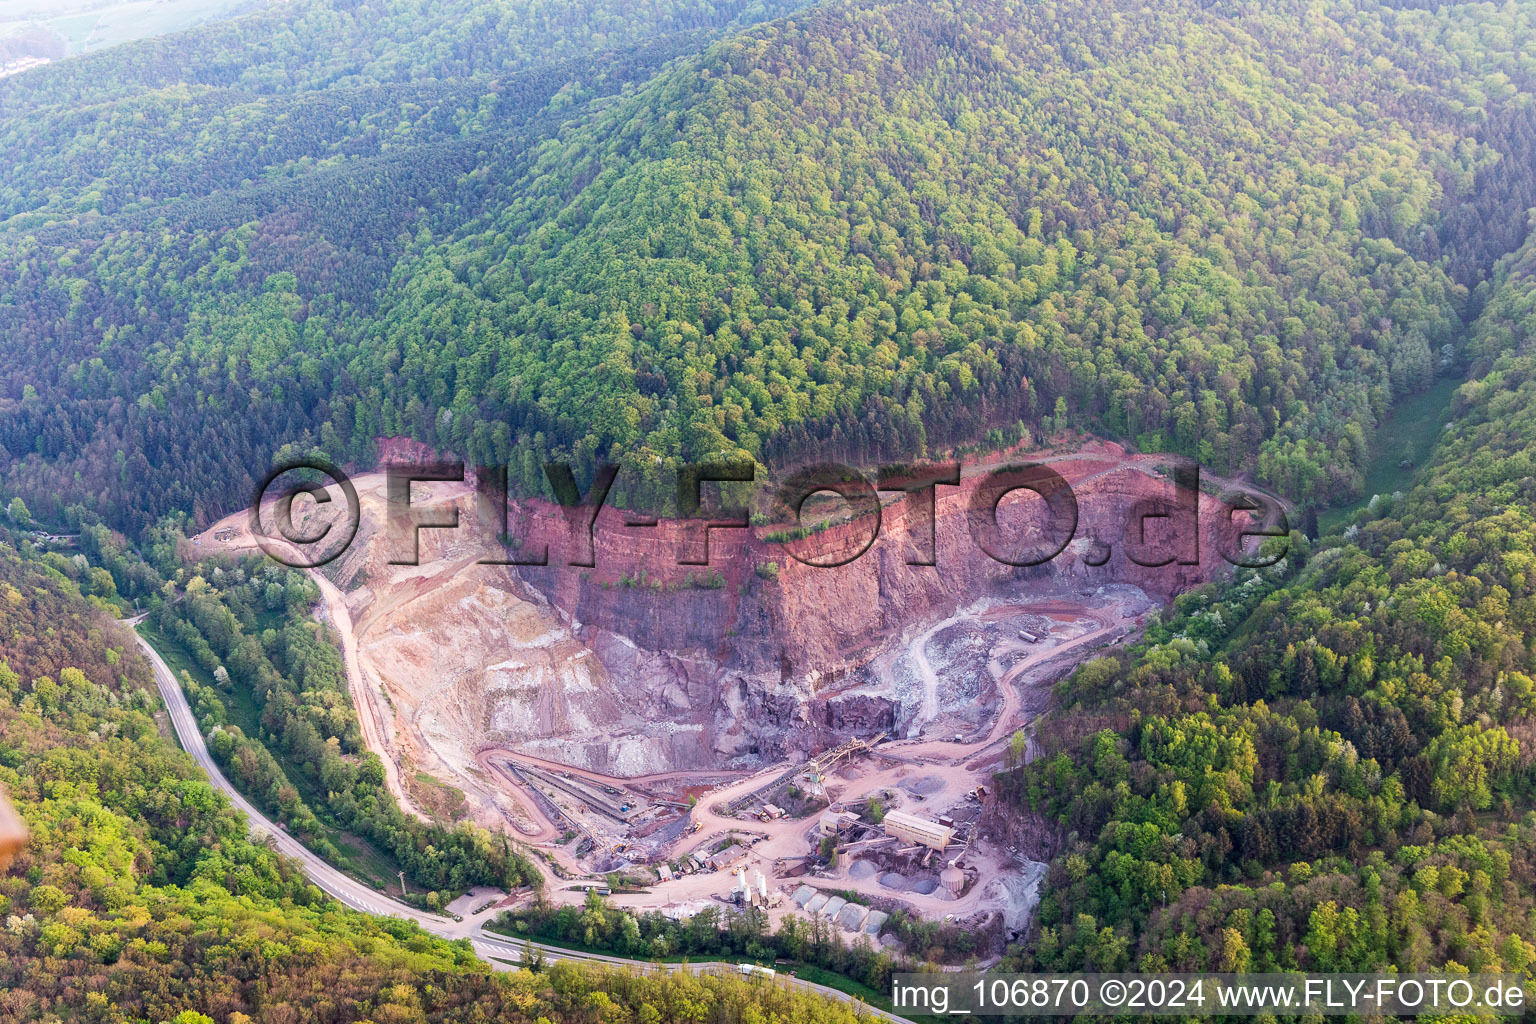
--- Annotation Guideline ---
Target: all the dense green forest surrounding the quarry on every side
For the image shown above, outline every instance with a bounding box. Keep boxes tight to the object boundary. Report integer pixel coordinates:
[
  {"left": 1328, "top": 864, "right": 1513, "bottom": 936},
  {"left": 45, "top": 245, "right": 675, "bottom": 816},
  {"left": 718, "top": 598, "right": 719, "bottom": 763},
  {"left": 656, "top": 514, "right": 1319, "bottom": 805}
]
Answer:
[{"left": 12, "top": 0, "right": 1536, "bottom": 1021}]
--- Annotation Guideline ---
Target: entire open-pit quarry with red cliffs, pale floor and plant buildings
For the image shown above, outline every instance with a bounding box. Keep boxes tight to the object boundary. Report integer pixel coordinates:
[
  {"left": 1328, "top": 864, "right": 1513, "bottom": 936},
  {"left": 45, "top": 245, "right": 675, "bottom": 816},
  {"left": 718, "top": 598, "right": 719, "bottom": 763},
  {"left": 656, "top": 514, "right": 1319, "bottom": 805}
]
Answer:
[{"left": 189, "top": 444, "right": 1271, "bottom": 964}]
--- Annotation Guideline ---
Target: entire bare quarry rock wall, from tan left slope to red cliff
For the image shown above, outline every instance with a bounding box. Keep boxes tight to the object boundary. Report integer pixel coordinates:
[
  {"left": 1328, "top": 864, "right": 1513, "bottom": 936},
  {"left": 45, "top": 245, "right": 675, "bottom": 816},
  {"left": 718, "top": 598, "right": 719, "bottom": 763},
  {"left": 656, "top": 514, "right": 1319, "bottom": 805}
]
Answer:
[{"left": 329, "top": 444, "right": 1271, "bottom": 779}]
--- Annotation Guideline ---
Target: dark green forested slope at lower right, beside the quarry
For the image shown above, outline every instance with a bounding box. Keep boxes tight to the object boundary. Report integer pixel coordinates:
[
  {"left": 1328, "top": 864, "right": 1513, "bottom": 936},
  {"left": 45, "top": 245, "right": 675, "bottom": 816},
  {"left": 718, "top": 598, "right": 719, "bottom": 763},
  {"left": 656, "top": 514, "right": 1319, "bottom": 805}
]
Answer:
[{"left": 1001, "top": 221, "right": 1536, "bottom": 972}]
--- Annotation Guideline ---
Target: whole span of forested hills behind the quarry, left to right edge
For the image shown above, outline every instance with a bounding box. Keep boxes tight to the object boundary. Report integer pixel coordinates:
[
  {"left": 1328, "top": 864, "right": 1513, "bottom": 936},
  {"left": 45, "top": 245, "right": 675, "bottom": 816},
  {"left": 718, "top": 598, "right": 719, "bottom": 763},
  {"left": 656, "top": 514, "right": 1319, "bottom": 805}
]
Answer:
[{"left": 9, "top": 0, "right": 1536, "bottom": 531}]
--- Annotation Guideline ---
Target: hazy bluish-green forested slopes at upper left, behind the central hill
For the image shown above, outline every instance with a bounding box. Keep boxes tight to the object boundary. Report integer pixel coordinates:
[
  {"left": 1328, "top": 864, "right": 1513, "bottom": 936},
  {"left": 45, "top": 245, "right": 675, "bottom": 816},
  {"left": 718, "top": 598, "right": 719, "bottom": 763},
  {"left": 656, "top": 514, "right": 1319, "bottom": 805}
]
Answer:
[{"left": 0, "top": 0, "right": 817, "bottom": 534}]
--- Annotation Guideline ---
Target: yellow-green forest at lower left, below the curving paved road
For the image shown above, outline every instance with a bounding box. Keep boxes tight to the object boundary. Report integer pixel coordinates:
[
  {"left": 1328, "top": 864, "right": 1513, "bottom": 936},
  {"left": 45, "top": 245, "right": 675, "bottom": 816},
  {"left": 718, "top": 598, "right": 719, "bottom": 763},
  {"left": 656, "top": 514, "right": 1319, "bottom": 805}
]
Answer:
[{"left": 0, "top": 543, "right": 872, "bottom": 1024}]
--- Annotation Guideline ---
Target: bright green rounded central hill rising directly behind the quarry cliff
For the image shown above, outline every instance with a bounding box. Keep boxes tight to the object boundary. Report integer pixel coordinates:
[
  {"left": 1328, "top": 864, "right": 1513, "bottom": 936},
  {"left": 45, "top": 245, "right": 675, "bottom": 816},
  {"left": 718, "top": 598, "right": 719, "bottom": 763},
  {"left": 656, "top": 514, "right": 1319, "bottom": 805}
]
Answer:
[{"left": 365, "top": 3, "right": 1495, "bottom": 493}]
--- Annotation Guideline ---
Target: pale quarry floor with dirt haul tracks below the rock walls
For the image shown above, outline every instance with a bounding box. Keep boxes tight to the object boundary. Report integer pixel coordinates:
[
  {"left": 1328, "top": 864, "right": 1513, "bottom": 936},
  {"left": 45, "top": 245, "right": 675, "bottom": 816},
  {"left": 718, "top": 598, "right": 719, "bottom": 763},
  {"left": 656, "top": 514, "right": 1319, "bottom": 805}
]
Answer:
[{"left": 192, "top": 474, "right": 1152, "bottom": 951}]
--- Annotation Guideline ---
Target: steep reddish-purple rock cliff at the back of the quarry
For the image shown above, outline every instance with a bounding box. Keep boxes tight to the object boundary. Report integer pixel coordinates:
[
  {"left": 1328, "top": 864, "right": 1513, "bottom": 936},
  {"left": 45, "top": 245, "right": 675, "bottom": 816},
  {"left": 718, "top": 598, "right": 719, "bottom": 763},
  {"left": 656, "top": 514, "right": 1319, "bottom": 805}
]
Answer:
[{"left": 417, "top": 445, "right": 1271, "bottom": 774}]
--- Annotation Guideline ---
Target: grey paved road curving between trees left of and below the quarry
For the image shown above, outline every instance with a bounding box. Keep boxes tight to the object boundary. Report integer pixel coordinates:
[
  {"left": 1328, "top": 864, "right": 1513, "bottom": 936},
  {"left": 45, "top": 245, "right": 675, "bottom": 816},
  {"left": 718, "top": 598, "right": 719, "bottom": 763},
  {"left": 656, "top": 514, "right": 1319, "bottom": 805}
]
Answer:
[{"left": 123, "top": 616, "right": 912, "bottom": 1024}]
